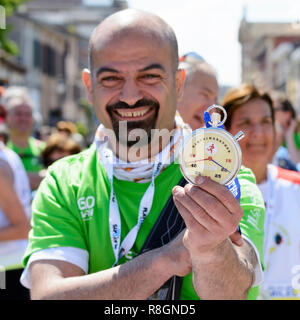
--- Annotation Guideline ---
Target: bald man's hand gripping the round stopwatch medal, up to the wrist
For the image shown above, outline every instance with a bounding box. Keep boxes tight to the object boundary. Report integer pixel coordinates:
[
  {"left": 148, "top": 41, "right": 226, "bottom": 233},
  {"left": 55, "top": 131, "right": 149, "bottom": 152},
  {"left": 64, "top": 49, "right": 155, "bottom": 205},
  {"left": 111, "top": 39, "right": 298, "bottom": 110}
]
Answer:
[{"left": 173, "top": 177, "right": 243, "bottom": 255}]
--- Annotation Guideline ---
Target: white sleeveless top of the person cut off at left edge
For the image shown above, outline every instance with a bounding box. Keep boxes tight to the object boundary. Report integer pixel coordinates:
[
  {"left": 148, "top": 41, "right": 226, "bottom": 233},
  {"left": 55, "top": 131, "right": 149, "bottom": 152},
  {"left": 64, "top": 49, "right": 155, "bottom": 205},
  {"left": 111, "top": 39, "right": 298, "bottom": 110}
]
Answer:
[{"left": 0, "top": 142, "right": 31, "bottom": 269}]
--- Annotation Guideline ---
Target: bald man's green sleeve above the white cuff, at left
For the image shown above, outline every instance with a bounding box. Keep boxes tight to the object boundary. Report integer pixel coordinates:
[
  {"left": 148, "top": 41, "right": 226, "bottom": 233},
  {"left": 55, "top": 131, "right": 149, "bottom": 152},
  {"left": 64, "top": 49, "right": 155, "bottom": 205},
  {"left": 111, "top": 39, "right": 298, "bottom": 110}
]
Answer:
[{"left": 23, "top": 163, "right": 87, "bottom": 265}]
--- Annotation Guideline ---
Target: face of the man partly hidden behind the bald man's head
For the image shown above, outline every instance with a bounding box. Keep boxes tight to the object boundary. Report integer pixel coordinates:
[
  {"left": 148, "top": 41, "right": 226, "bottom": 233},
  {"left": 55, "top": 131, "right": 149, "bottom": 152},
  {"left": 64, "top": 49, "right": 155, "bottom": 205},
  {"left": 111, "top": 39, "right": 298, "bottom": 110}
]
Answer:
[{"left": 178, "top": 71, "right": 219, "bottom": 130}]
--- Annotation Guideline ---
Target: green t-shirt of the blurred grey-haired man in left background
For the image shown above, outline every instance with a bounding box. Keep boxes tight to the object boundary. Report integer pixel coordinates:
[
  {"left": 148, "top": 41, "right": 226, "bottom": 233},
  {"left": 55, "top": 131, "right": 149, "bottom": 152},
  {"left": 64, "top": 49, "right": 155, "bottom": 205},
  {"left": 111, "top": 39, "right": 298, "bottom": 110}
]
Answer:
[{"left": 7, "top": 137, "right": 46, "bottom": 172}]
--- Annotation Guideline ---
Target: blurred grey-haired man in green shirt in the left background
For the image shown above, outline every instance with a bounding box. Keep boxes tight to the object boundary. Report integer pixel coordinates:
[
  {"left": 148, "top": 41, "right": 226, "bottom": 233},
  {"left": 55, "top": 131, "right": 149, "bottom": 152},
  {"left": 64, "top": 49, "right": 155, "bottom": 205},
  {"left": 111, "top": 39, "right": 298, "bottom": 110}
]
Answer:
[{"left": 4, "top": 87, "right": 45, "bottom": 190}]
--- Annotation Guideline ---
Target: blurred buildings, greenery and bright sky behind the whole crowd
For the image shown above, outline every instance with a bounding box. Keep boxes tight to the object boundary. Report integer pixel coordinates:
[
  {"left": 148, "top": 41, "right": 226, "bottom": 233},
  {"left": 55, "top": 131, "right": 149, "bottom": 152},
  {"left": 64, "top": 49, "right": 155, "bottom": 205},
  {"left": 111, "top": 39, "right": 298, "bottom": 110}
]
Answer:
[{"left": 0, "top": 0, "right": 300, "bottom": 142}]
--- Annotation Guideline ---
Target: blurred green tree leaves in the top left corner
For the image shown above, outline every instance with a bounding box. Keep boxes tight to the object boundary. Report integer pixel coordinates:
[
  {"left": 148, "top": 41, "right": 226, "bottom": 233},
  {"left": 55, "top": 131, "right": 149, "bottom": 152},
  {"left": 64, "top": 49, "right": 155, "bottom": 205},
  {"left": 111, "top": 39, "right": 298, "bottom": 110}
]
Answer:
[{"left": 0, "top": 0, "right": 28, "bottom": 55}]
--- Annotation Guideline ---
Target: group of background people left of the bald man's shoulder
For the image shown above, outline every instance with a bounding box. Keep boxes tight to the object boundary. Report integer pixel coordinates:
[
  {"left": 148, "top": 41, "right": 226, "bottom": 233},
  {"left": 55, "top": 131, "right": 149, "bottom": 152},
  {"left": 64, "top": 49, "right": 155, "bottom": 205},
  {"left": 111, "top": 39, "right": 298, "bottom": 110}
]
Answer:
[{"left": 0, "top": 86, "right": 83, "bottom": 299}]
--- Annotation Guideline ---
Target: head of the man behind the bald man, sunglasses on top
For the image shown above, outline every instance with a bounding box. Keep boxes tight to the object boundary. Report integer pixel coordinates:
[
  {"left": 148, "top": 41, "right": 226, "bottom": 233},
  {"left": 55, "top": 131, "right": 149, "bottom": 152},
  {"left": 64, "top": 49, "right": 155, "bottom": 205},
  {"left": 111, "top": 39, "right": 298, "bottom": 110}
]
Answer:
[{"left": 178, "top": 52, "right": 219, "bottom": 130}]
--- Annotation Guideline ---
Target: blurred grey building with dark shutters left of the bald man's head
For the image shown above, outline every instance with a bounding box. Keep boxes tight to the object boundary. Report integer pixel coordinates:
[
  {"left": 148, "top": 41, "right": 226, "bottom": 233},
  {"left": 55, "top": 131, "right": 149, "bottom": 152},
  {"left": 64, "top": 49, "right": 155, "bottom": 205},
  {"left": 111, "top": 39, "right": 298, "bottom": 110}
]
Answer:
[{"left": 0, "top": 0, "right": 127, "bottom": 129}]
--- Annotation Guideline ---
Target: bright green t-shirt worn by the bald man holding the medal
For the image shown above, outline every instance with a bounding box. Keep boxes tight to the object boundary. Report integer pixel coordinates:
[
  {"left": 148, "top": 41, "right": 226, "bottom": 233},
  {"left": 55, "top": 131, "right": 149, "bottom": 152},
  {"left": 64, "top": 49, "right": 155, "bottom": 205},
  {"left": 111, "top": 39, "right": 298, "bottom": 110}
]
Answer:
[{"left": 24, "top": 145, "right": 264, "bottom": 299}]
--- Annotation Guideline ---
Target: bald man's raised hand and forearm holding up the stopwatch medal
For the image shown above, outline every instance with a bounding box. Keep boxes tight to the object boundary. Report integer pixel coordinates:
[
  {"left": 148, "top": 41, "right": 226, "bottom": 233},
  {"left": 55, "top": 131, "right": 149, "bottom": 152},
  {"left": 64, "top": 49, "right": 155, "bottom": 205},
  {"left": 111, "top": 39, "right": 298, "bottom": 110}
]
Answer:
[{"left": 173, "top": 177, "right": 257, "bottom": 300}]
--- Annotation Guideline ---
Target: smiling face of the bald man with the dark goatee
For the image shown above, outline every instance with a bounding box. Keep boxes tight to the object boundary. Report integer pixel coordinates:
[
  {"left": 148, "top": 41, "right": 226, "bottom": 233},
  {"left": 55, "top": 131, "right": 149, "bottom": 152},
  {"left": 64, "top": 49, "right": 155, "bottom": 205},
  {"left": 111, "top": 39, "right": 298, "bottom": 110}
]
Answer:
[{"left": 84, "top": 33, "right": 182, "bottom": 146}]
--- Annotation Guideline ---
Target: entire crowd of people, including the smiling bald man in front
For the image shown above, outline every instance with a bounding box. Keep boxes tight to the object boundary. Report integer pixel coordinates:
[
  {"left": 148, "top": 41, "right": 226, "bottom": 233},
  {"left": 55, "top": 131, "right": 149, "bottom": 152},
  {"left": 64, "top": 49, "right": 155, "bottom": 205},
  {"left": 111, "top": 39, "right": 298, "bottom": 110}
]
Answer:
[{"left": 0, "top": 9, "right": 300, "bottom": 300}]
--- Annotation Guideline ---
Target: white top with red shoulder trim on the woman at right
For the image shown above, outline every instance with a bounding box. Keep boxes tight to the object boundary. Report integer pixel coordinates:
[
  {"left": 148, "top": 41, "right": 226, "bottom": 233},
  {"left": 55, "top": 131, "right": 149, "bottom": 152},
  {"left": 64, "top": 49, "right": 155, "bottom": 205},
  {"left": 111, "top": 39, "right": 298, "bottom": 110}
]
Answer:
[{"left": 258, "top": 165, "right": 300, "bottom": 299}]
